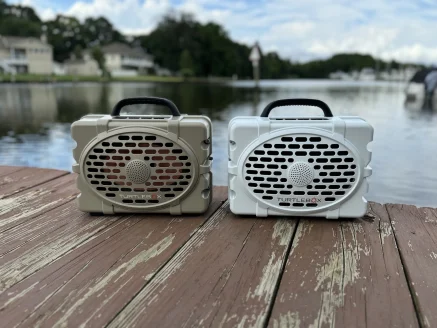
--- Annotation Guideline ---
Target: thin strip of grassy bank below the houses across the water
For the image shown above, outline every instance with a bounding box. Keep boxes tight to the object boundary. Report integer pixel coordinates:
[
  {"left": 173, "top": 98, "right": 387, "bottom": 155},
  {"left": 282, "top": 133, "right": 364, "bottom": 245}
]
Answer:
[{"left": 0, "top": 74, "right": 235, "bottom": 83}]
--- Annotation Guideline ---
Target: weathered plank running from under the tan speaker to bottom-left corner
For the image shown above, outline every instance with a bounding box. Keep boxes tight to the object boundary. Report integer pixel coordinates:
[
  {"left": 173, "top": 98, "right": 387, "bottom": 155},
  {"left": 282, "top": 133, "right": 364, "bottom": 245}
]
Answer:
[{"left": 0, "top": 187, "right": 227, "bottom": 327}]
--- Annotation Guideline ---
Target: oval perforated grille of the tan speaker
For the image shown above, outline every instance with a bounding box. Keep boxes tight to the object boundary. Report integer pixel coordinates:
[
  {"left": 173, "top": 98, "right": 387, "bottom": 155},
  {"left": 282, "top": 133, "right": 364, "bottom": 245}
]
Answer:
[{"left": 84, "top": 133, "right": 193, "bottom": 207}]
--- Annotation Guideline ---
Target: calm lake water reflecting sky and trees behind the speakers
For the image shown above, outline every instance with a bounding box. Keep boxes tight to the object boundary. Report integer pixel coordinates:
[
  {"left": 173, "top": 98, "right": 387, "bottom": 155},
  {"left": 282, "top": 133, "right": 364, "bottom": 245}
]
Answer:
[{"left": 0, "top": 80, "right": 437, "bottom": 206}]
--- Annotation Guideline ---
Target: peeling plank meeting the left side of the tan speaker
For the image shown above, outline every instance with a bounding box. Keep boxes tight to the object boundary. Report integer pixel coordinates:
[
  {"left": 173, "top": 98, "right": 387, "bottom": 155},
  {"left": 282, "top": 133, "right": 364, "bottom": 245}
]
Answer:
[{"left": 0, "top": 174, "right": 79, "bottom": 234}]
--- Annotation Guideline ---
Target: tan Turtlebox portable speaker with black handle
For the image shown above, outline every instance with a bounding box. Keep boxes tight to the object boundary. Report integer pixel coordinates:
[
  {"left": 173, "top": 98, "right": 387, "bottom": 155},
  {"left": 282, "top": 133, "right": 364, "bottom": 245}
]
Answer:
[{"left": 71, "top": 97, "right": 212, "bottom": 214}]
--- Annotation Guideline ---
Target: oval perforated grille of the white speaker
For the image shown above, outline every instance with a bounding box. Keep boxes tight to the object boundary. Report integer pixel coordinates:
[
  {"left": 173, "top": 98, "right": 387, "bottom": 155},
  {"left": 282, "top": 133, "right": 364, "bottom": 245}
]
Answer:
[{"left": 243, "top": 134, "right": 359, "bottom": 208}]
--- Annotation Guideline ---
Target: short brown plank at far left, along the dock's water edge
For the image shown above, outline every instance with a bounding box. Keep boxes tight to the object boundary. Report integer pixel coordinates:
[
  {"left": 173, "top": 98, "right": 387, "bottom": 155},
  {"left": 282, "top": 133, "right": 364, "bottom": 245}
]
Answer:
[{"left": 0, "top": 167, "right": 69, "bottom": 199}]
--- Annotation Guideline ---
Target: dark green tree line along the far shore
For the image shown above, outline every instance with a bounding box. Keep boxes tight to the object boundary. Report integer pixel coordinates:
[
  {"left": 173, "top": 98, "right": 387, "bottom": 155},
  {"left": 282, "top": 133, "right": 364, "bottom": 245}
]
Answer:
[{"left": 0, "top": 0, "right": 416, "bottom": 79}]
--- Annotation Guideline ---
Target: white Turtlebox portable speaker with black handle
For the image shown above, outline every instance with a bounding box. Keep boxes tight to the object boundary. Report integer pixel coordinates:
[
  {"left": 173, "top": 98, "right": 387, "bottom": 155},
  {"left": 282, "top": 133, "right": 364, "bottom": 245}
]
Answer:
[{"left": 228, "top": 99, "right": 373, "bottom": 219}]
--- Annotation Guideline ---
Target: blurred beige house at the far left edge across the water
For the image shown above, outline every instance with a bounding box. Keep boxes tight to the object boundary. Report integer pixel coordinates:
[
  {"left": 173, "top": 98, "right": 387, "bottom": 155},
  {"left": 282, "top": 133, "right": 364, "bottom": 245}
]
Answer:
[{"left": 0, "top": 36, "right": 53, "bottom": 74}]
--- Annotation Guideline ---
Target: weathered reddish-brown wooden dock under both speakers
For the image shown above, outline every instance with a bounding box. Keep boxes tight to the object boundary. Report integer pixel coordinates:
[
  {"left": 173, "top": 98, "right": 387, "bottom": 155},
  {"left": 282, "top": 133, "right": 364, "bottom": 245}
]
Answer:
[{"left": 0, "top": 167, "right": 437, "bottom": 327}]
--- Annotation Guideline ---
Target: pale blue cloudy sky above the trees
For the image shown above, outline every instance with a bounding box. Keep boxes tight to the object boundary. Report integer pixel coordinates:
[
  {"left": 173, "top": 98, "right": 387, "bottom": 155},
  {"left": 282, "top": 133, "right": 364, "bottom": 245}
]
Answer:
[{"left": 8, "top": 0, "right": 437, "bottom": 65}]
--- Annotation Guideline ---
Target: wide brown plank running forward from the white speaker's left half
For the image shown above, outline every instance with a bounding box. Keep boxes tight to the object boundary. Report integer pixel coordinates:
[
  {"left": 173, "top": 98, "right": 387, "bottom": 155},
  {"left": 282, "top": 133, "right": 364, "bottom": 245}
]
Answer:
[{"left": 109, "top": 204, "right": 295, "bottom": 327}]
